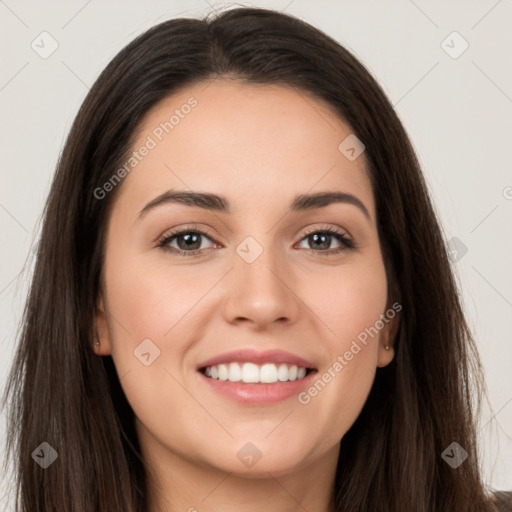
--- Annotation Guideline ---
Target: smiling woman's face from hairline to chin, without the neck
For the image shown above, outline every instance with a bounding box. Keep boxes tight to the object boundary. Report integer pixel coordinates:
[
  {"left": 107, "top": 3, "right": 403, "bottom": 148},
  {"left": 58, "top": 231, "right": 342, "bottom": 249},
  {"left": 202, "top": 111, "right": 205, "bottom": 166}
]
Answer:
[{"left": 96, "top": 80, "right": 394, "bottom": 476}]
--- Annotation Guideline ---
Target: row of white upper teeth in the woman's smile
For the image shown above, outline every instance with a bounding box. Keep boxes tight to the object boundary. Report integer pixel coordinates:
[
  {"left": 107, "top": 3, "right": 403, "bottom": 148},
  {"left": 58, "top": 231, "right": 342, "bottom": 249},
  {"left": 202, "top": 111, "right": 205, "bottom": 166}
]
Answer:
[{"left": 204, "top": 363, "right": 307, "bottom": 384}]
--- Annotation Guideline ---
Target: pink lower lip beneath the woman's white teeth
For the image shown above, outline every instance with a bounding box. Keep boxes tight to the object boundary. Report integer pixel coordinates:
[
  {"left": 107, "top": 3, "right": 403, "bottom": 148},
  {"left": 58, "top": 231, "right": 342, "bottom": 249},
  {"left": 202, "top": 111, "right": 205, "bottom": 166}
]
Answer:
[{"left": 197, "top": 370, "right": 317, "bottom": 405}]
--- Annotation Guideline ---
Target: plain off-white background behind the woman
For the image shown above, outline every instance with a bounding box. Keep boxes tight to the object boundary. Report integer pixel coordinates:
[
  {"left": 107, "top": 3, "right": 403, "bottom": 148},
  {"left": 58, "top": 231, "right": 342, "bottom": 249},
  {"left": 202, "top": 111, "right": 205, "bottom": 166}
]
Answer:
[{"left": 0, "top": 0, "right": 512, "bottom": 509}]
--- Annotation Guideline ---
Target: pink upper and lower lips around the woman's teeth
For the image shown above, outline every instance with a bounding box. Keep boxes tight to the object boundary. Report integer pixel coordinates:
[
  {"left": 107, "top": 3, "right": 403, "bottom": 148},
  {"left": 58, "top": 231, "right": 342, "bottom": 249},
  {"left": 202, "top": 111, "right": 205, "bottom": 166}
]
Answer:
[{"left": 196, "top": 349, "right": 317, "bottom": 406}]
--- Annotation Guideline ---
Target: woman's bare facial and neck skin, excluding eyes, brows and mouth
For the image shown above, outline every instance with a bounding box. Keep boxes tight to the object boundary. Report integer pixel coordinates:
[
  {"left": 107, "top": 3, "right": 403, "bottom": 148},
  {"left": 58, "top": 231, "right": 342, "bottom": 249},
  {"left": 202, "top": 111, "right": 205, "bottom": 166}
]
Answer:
[{"left": 94, "top": 79, "right": 396, "bottom": 512}]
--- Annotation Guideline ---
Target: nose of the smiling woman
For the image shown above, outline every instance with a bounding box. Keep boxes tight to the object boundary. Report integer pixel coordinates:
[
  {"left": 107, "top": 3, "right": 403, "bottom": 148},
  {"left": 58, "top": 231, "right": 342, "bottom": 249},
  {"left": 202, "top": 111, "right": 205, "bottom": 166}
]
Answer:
[{"left": 223, "top": 244, "right": 300, "bottom": 330}]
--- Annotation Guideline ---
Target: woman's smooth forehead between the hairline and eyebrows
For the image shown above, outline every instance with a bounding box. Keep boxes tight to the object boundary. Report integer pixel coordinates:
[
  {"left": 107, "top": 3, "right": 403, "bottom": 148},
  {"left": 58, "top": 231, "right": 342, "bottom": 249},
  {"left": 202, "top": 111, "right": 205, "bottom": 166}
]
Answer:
[{"left": 116, "top": 79, "right": 373, "bottom": 216}]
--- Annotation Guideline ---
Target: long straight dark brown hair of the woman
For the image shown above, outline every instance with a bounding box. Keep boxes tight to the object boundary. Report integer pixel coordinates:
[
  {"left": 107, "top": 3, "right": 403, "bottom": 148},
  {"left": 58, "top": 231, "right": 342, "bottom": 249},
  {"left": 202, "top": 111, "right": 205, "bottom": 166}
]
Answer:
[{"left": 5, "top": 8, "right": 508, "bottom": 512}]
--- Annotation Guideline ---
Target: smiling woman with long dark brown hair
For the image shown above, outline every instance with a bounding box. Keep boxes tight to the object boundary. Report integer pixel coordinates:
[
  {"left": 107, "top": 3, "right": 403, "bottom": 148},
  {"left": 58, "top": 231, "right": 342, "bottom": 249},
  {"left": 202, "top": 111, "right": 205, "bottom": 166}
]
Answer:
[{"left": 2, "top": 8, "right": 506, "bottom": 512}]
